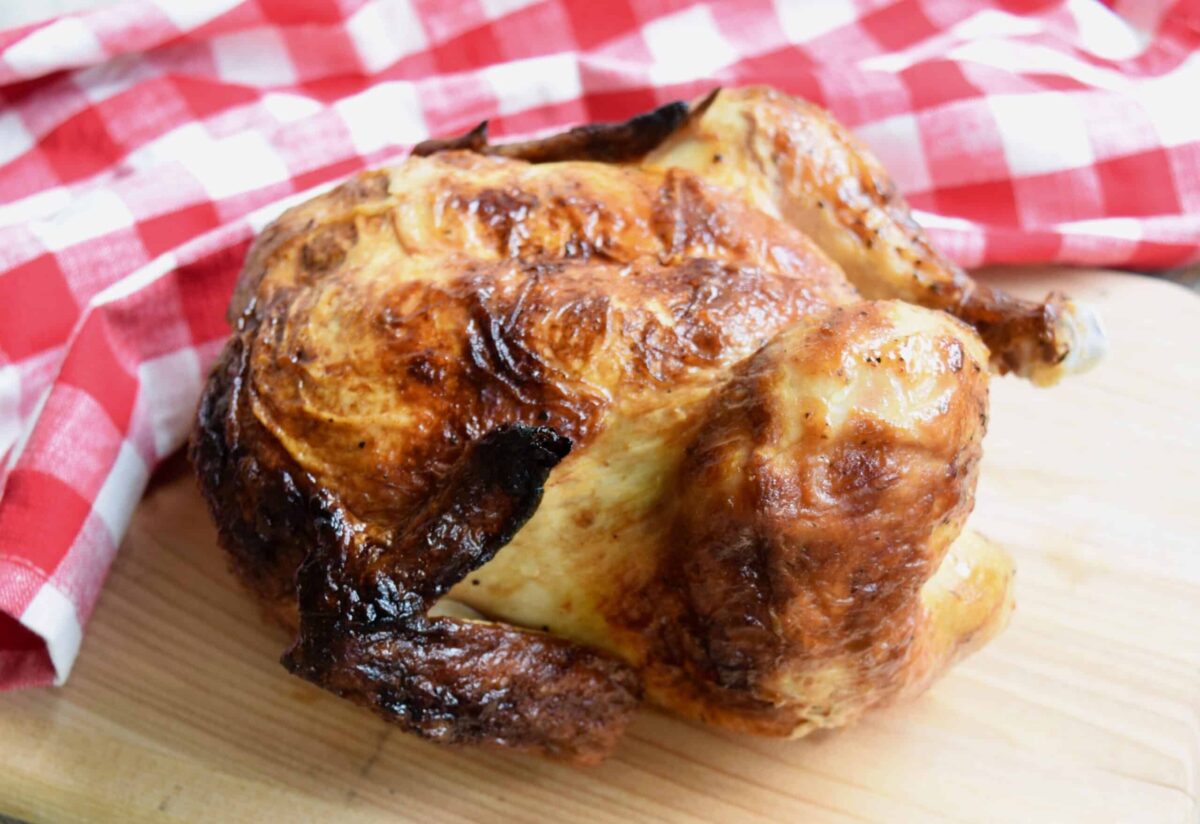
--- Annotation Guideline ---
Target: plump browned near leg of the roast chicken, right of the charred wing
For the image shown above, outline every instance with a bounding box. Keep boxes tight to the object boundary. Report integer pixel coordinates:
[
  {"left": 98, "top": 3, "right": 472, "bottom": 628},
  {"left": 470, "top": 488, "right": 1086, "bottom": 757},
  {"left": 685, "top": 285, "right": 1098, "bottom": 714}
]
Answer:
[{"left": 630, "top": 302, "right": 993, "bottom": 735}]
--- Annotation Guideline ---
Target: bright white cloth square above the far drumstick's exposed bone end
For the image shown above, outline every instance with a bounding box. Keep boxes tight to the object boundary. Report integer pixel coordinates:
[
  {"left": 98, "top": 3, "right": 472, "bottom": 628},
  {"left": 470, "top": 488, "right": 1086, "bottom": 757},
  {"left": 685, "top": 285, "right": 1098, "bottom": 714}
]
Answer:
[{"left": 988, "top": 91, "right": 1094, "bottom": 175}]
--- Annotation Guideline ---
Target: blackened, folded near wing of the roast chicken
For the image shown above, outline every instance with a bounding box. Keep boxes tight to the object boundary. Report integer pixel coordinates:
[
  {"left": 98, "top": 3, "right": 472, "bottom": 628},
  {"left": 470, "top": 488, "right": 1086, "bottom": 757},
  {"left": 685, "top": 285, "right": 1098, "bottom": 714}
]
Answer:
[{"left": 283, "top": 425, "right": 637, "bottom": 762}]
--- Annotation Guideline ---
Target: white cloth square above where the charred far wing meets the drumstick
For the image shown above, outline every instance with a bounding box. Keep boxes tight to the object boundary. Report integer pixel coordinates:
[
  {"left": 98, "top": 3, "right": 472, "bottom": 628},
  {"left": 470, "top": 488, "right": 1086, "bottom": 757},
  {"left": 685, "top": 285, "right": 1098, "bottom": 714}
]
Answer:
[{"left": 642, "top": 6, "right": 738, "bottom": 84}]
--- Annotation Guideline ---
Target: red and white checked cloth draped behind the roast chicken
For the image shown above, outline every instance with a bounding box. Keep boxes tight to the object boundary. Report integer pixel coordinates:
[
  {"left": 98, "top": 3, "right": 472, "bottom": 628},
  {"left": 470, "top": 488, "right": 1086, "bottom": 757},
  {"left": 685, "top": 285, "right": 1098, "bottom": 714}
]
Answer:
[{"left": 0, "top": 0, "right": 1200, "bottom": 688}]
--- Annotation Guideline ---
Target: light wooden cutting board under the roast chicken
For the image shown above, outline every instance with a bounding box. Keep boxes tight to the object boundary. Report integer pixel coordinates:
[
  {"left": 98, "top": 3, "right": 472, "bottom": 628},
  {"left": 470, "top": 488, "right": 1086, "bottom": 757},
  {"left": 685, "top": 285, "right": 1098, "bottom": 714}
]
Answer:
[{"left": 0, "top": 271, "right": 1200, "bottom": 823}]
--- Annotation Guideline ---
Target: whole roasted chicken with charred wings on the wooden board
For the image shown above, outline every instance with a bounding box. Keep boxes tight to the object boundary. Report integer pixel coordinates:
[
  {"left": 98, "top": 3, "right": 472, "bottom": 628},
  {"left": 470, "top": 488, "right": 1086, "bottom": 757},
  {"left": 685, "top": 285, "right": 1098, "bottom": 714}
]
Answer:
[{"left": 192, "top": 89, "right": 1102, "bottom": 762}]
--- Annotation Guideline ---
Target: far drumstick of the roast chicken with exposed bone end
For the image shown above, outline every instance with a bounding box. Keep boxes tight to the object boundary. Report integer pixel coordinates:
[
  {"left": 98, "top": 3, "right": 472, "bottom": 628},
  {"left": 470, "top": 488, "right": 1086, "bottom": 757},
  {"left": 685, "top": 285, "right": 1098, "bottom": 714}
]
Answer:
[{"left": 641, "top": 88, "right": 1105, "bottom": 385}]
